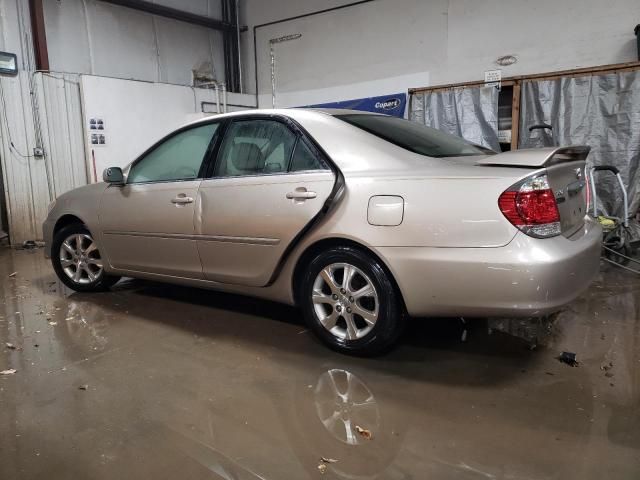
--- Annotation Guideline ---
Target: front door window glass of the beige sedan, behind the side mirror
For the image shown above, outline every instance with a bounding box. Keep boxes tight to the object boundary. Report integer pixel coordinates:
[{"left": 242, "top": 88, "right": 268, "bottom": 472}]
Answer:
[{"left": 127, "top": 123, "right": 218, "bottom": 183}]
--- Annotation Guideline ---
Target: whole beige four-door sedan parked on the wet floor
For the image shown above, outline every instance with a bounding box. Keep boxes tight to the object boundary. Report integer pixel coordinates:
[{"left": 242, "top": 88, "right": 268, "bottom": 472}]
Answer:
[{"left": 44, "top": 109, "right": 601, "bottom": 354}]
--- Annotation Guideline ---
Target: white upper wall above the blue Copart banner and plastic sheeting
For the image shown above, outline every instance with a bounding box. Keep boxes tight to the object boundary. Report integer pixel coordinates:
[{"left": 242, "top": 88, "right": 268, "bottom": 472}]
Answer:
[{"left": 243, "top": 0, "right": 640, "bottom": 106}]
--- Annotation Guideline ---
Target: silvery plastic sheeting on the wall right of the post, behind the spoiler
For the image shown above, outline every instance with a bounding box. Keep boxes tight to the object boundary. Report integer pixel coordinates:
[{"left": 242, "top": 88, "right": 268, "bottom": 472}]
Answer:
[{"left": 518, "top": 71, "right": 640, "bottom": 223}]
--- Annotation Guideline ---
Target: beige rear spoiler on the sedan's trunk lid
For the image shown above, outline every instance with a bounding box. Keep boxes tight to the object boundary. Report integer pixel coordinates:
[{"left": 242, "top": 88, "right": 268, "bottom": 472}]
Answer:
[{"left": 476, "top": 145, "right": 591, "bottom": 168}]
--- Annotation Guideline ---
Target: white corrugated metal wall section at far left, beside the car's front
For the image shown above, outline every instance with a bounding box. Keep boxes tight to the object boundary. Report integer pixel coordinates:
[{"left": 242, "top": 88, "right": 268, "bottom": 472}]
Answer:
[{"left": 0, "top": 72, "right": 87, "bottom": 244}]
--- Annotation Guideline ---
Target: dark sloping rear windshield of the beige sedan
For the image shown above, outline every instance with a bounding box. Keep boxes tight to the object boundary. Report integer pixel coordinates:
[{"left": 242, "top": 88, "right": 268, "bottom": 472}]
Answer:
[{"left": 336, "top": 114, "right": 495, "bottom": 158}]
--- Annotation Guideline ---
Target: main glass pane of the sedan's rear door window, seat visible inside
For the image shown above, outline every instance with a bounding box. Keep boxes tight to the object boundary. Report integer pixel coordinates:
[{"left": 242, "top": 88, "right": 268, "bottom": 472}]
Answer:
[{"left": 215, "top": 120, "right": 296, "bottom": 177}]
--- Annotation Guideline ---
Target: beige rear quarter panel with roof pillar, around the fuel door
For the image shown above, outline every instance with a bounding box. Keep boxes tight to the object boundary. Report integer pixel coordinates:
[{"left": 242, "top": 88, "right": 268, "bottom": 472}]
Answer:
[{"left": 290, "top": 110, "right": 536, "bottom": 248}]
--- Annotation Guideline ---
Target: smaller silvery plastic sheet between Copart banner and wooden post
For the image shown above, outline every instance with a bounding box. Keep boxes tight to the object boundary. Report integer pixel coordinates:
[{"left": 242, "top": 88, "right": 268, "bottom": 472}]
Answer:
[{"left": 409, "top": 87, "right": 500, "bottom": 152}]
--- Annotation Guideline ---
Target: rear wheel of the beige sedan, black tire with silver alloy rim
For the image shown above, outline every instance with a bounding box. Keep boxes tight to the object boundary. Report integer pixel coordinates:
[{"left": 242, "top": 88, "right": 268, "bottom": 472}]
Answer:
[{"left": 300, "top": 247, "right": 404, "bottom": 356}]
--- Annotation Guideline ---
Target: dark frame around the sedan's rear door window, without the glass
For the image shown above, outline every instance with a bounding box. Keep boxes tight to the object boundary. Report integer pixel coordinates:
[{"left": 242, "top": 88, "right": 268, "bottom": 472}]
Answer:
[{"left": 204, "top": 114, "right": 333, "bottom": 180}]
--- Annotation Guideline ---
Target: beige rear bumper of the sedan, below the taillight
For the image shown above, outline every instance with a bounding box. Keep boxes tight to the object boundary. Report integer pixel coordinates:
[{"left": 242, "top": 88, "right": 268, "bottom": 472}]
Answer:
[{"left": 376, "top": 219, "right": 602, "bottom": 317}]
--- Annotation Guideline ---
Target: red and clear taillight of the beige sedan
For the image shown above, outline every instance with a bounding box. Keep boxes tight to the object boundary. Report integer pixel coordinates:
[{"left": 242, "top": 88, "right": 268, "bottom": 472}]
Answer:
[{"left": 498, "top": 175, "right": 561, "bottom": 238}]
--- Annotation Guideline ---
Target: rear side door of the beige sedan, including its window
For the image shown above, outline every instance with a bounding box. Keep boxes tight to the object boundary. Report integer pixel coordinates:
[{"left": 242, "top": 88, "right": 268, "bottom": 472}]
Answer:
[{"left": 196, "top": 117, "right": 335, "bottom": 286}]
